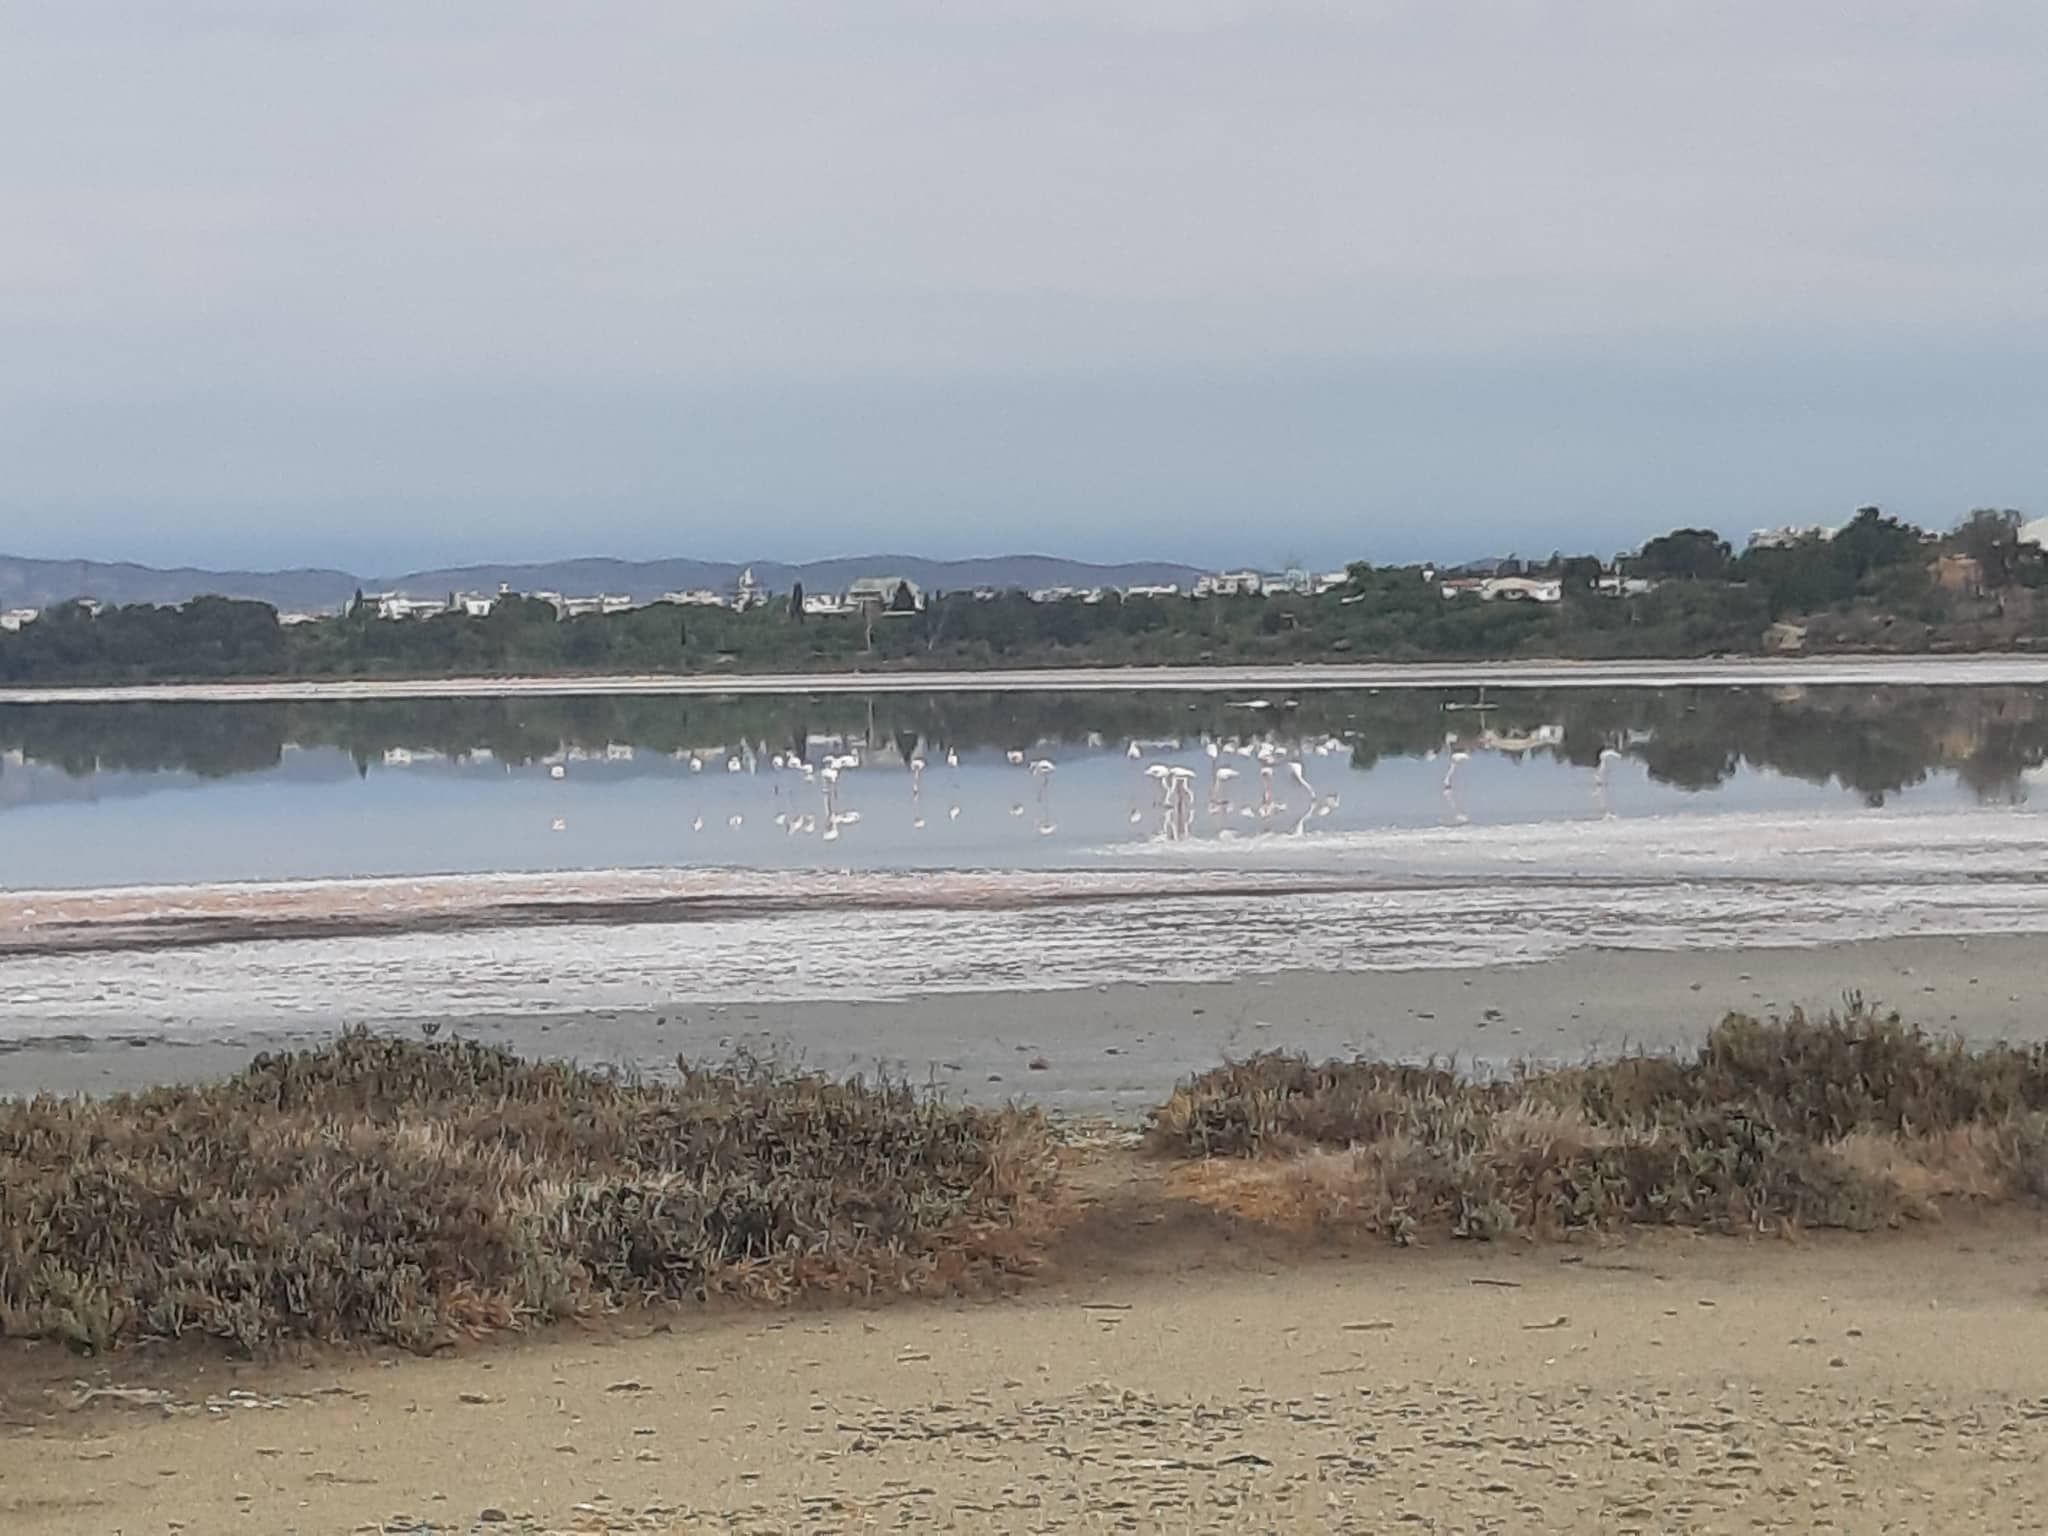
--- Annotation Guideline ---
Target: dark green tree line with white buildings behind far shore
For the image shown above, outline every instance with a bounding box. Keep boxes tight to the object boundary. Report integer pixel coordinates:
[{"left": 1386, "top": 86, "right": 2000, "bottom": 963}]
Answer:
[{"left": 0, "top": 508, "right": 2048, "bottom": 684}]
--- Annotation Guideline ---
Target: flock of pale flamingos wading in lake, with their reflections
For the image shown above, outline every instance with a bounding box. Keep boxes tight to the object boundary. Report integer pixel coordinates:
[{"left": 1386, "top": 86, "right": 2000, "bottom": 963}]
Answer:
[{"left": 549, "top": 735, "right": 1622, "bottom": 842}]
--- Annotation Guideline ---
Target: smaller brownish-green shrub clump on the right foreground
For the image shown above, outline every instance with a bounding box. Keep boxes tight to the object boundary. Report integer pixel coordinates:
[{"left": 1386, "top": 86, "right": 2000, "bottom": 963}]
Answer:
[{"left": 1151, "top": 999, "right": 2048, "bottom": 1241}]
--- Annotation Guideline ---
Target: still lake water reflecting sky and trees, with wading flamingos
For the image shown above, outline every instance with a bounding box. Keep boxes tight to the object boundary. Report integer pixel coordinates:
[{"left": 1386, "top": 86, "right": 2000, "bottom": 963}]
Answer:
[{"left": 0, "top": 686, "right": 2048, "bottom": 889}]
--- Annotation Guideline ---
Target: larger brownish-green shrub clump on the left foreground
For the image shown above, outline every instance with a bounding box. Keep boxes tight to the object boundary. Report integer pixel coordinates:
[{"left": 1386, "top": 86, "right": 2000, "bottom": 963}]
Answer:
[{"left": 0, "top": 1032, "right": 1055, "bottom": 1350}]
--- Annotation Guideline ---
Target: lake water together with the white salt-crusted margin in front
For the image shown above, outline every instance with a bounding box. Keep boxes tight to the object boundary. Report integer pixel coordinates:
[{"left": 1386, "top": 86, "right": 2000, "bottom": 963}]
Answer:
[{"left": 0, "top": 686, "right": 2048, "bottom": 1038}]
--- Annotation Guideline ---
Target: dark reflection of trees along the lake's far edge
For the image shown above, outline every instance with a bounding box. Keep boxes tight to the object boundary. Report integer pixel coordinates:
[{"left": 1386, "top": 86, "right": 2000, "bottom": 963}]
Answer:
[{"left": 0, "top": 688, "right": 2048, "bottom": 805}]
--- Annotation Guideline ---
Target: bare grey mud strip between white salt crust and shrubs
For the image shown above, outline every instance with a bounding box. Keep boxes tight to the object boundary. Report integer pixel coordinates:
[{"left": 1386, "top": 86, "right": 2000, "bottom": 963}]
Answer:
[{"left": 12, "top": 936, "right": 2048, "bottom": 1120}]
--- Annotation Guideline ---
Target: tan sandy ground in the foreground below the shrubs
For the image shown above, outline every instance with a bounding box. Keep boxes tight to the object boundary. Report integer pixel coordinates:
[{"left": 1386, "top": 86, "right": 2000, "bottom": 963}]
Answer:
[{"left": 0, "top": 1210, "right": 2048, "bottom": 1536}]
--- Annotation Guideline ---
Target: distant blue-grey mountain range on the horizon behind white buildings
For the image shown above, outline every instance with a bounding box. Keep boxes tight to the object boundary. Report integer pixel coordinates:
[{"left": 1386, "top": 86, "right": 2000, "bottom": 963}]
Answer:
[{"left": 0, "top": 555, "right": 1200, "bottom": 612}]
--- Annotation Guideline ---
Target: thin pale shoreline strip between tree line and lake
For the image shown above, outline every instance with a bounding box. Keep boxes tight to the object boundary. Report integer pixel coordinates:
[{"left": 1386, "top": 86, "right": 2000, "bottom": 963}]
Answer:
[{"left": 12, "top": 653, "right": 2048, "bottom": 705}]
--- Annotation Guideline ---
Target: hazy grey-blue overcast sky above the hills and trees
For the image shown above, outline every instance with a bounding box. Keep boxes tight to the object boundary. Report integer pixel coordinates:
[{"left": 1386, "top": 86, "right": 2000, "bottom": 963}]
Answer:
[{"left": 0, "top": 0, "right": 2048, "bottom": 571}]
